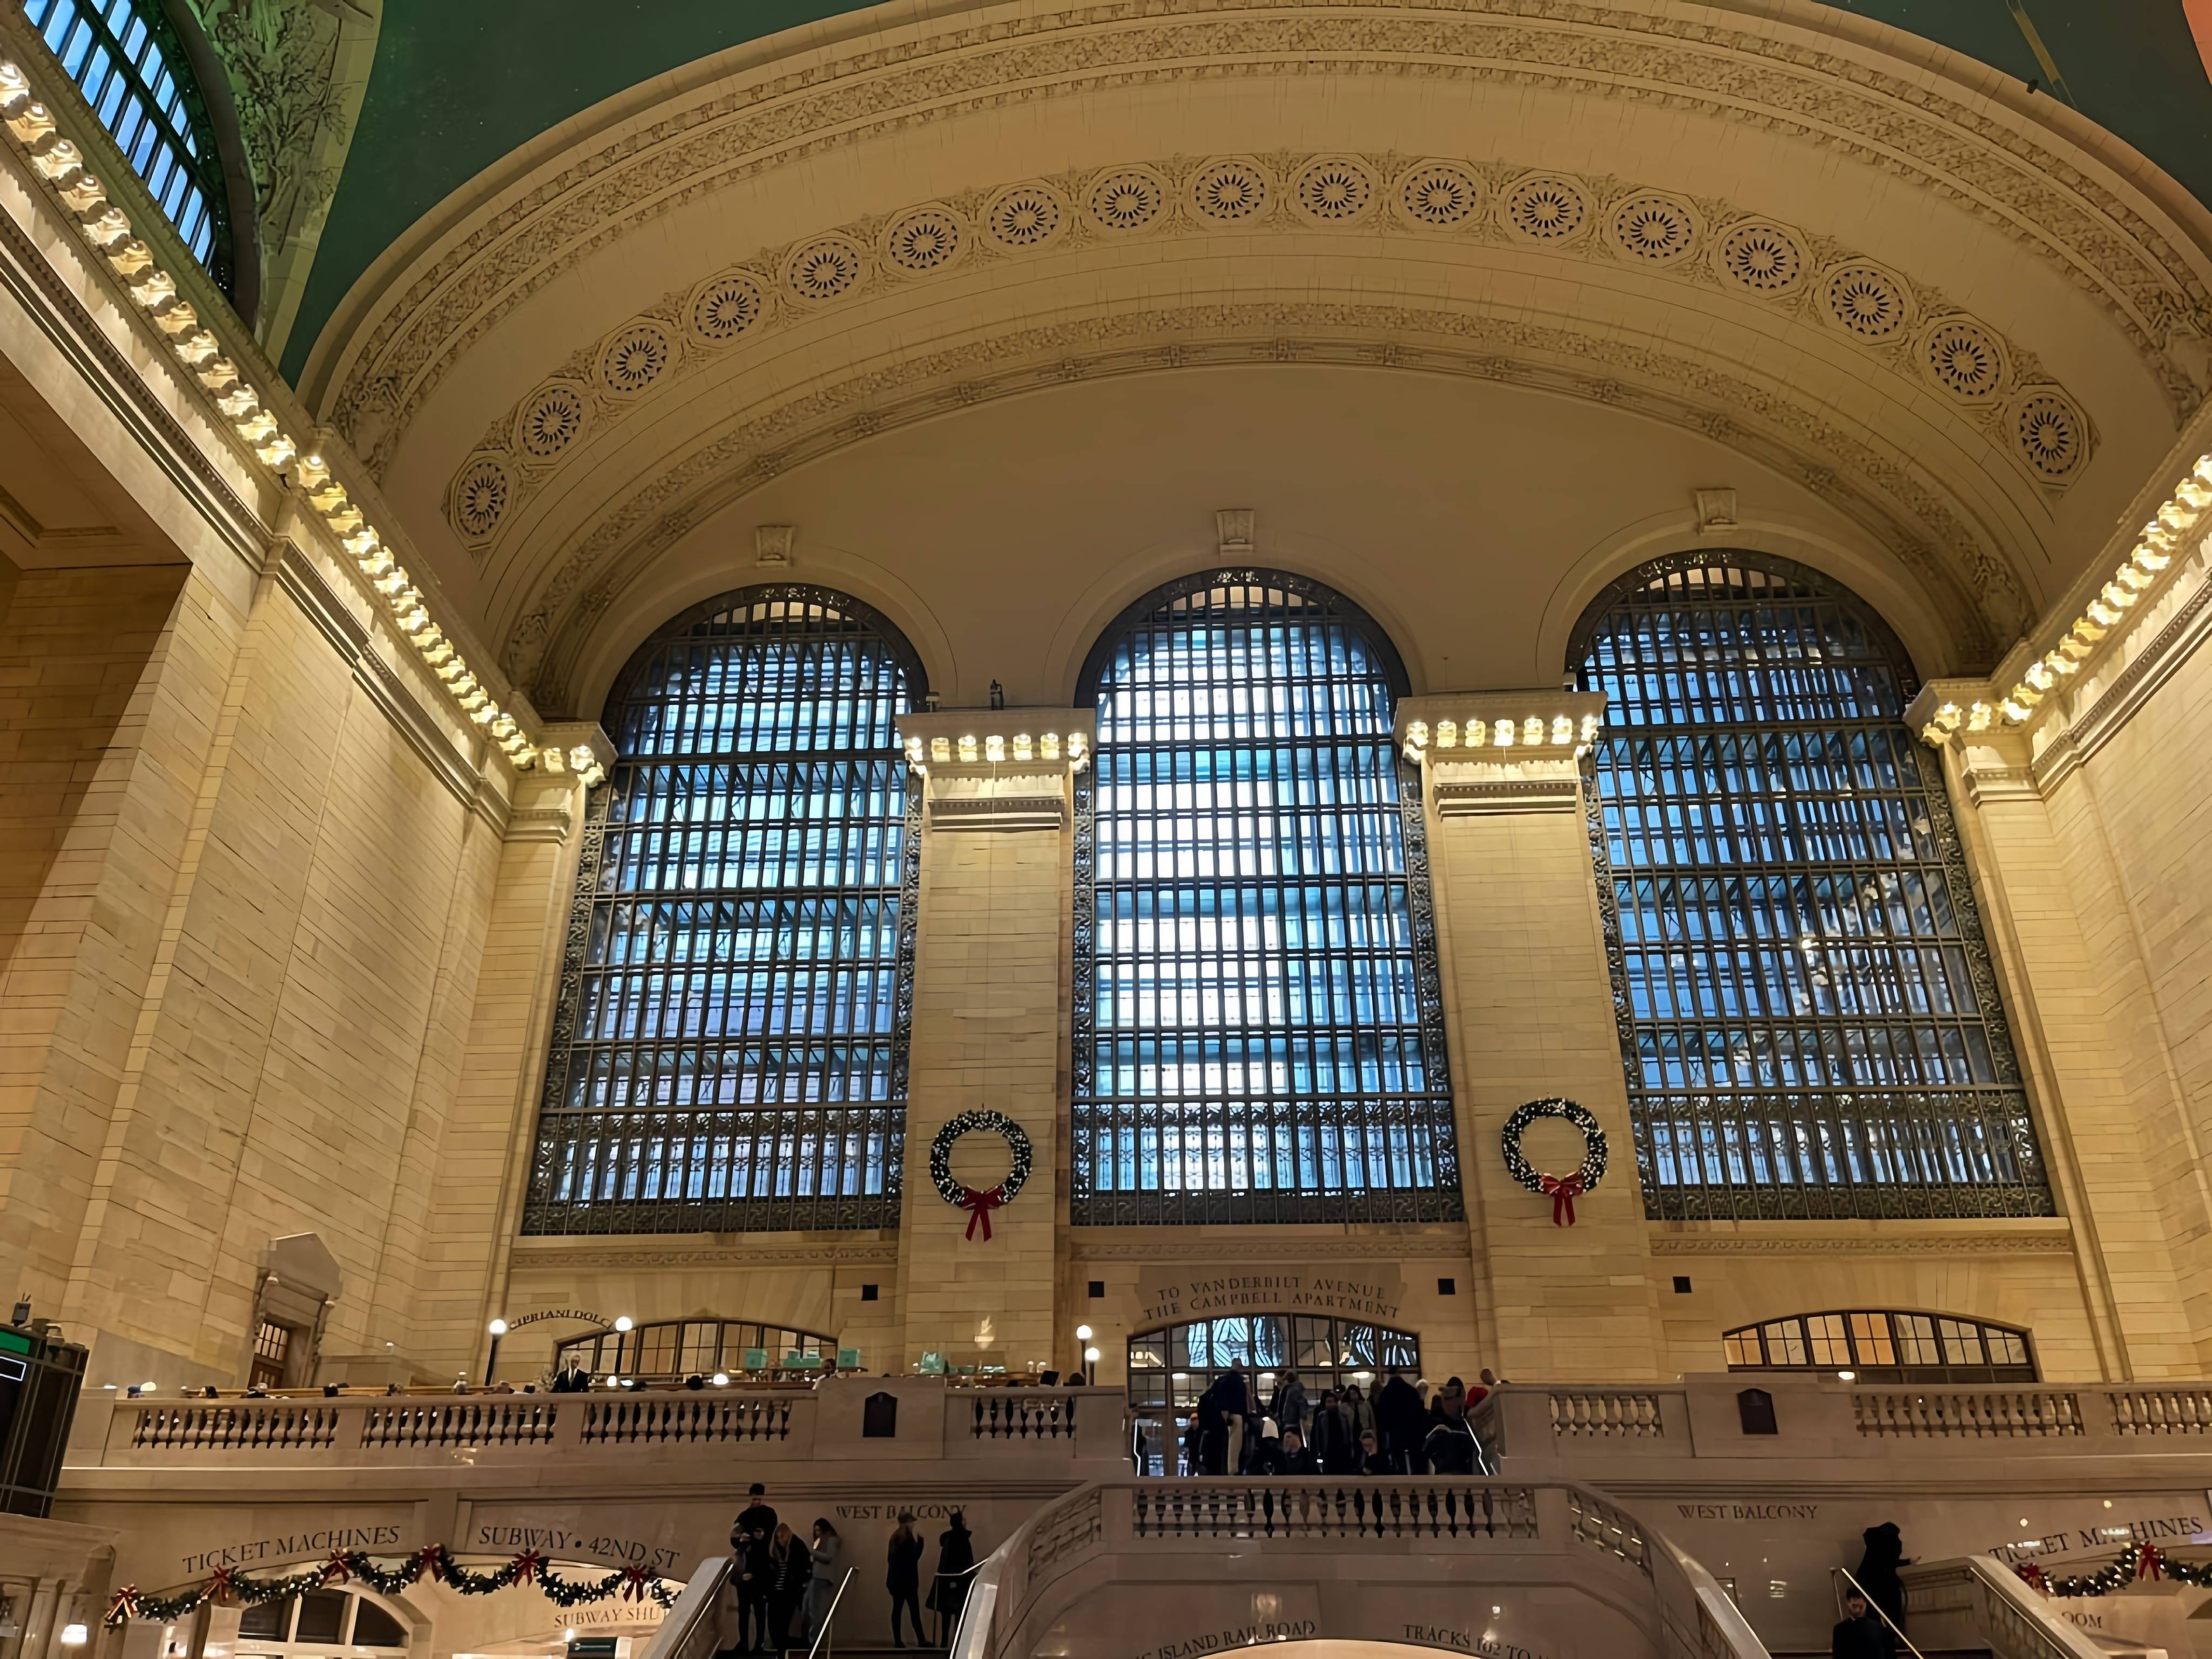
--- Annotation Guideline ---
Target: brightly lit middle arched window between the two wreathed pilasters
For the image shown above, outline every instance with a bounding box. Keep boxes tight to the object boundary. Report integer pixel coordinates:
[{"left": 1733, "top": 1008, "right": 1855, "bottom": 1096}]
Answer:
[{"left": 1073, "top": 571, "right": 1462, "bottom": 1223}]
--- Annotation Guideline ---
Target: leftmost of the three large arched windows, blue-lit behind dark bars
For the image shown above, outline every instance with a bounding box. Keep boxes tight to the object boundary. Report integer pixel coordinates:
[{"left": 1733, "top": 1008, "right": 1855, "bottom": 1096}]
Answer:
[{"left": 524, "top": 586, "right": 922, "bottom": 1232}]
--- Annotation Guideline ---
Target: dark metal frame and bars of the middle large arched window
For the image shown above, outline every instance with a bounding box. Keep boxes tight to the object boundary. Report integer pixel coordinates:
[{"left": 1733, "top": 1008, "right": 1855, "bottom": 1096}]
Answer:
[{"left": 1070, "top": 567, "right": 1467, "bottom": 1225}]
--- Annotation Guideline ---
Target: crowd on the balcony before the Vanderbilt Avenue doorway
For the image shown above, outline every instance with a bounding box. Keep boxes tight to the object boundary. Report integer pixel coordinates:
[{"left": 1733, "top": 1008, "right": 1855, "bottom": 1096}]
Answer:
[{"left": 1137, "top": 1367, "right": 1498, "bottom": 1475}]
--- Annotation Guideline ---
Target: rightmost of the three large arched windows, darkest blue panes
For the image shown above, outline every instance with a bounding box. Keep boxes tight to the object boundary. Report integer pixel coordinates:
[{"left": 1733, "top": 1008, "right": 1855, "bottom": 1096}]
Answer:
[{"left": 1573, "top": 553, "right": 2051, "bottom": 1219}]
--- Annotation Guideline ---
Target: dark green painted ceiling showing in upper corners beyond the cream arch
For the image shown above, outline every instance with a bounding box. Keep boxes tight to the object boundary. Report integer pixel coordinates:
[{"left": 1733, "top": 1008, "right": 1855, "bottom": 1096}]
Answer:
[{"left": 283, "top": 0, "right": 2212, "bottom": 381}]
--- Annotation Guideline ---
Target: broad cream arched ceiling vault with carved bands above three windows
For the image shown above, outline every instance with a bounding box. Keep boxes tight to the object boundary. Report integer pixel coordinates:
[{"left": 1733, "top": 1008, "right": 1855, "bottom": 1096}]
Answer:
[{"left": 285, "top": 0, "right": 2212, "bottom": 712}]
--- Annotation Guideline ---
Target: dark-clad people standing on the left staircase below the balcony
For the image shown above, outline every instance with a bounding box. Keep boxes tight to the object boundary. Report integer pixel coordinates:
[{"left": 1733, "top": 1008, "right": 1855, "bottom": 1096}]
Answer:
[{"left": 717, "top": 1482, "right": 975, "bottom": 1659}]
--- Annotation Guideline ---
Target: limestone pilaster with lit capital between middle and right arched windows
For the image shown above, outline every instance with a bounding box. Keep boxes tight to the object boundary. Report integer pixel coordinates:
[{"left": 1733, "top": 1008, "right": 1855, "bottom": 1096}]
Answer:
[{"left": 1398, "top": 690, "right": 1657, "bottom": 1378}]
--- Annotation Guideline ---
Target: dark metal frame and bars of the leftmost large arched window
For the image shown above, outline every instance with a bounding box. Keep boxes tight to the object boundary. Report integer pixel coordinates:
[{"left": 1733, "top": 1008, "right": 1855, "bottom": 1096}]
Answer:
[{"left": 522, "top": 582, "right": 927, "bottom": 1235}]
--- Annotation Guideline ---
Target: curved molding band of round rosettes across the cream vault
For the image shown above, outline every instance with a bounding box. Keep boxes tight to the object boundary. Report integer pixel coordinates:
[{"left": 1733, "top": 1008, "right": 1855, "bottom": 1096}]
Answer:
[{"left": 444, "top": 155, "right": 2095, "bottom": 553}]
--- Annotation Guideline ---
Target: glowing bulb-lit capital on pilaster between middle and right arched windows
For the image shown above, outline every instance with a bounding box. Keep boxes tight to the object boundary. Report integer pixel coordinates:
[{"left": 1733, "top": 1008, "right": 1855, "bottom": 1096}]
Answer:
[{"left": 1398, "top": 688, "right": 1606, "bottom": 819}]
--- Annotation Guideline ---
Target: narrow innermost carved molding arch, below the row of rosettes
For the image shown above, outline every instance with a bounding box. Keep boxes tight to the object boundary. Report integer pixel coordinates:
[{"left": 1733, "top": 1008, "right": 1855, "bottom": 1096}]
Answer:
[{"left": 504, "top": 301, "right": 2028, "bottom": 708}]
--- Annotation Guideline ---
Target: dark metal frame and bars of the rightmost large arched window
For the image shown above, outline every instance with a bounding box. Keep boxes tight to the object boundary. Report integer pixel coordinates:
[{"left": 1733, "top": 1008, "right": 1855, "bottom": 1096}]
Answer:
[{"left": 1568, "top": 559, "right": 2055, "bottom": 1221}]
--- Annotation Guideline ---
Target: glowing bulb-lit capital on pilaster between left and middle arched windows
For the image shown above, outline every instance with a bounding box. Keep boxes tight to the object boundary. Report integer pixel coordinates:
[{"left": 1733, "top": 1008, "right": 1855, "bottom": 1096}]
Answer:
[{"left": 898, "top": 708, "right": 1097, "bottom": 832}]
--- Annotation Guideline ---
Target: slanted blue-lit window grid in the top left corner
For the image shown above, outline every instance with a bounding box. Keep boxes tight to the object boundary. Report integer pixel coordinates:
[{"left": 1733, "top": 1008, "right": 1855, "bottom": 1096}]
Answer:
[{"left": 24, "top": 0, "right": 230, "bottom": 276}]
